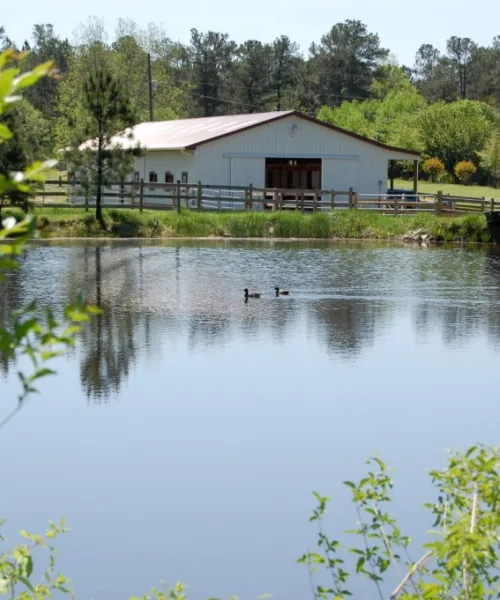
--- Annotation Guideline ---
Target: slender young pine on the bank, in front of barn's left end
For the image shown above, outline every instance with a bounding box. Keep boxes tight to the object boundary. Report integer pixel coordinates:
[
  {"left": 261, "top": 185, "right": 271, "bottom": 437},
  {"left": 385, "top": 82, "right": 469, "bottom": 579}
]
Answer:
[{"left": 67, "top": 68, "right": 140, "bottom": 227}]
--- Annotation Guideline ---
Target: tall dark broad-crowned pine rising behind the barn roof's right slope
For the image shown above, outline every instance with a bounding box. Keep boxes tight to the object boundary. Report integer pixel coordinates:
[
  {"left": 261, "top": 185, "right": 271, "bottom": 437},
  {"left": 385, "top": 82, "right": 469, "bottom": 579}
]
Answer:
[{"left": 309, "top": 20, "right": 389, "bottom": 105}]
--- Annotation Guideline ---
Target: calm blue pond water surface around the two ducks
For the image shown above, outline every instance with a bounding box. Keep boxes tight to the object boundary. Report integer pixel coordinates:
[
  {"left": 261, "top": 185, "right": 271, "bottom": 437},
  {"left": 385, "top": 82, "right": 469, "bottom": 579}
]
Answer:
[{"left": 0, "top": 242, "right": 500, "bottom": 600}]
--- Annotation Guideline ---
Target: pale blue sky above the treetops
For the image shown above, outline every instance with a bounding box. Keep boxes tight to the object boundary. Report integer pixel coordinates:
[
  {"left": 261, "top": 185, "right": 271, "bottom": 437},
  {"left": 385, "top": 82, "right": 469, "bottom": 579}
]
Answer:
[{"left": 4, "top": 0, "right": 500, "bottom": 64}]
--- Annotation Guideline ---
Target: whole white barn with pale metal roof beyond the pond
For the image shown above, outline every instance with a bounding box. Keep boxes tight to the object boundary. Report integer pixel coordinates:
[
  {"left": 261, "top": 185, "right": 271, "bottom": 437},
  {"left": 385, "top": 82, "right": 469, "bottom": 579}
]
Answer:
[{"left": 79, "top": 111, "right": 420, "bottom": 199}]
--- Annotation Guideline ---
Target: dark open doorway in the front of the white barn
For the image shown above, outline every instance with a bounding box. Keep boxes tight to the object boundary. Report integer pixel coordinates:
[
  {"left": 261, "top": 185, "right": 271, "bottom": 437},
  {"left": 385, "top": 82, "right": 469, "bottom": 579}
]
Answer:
[{"left": 266, "top": 158, "right": 321, "bottom": 190}]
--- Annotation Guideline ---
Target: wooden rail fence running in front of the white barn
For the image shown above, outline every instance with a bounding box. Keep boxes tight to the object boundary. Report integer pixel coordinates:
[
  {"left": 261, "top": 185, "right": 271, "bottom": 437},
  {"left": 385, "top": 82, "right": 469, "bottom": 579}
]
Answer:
[{"left": 19, "top": 178, "right": 500, "bottom": 216}]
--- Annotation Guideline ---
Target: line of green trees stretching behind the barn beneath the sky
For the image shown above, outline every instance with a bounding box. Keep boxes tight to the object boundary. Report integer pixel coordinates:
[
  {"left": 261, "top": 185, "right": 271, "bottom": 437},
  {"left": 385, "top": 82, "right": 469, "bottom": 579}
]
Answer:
[{"left": 0, "top": 20, "right": 500, "bottom": 184}]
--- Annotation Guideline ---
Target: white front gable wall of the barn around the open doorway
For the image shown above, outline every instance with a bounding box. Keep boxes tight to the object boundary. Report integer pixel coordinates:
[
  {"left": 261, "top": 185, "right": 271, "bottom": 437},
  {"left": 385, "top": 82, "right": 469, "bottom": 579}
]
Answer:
[{"left": 194, "top": 115, "right": 415, "bottom": 194}]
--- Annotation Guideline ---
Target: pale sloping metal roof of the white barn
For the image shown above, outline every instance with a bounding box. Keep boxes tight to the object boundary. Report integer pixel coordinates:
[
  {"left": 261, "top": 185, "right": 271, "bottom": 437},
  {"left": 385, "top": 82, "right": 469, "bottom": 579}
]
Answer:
[{"left": 80, "top": 110, "right": 420, "bottom": 156}]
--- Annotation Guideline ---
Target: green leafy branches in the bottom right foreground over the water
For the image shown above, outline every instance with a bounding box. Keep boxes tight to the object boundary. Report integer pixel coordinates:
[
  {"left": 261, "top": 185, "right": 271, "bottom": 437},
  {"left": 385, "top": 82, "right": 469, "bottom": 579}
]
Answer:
[{"left": 299, "top": 446, "right": 500, "bottom": 600}]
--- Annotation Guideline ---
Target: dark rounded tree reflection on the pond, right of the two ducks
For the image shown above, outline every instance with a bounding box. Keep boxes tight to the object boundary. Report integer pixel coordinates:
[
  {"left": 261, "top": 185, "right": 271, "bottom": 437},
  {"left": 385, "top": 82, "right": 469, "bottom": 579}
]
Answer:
[{"left": 309, "top": 298, "right": 392, "bottom": 358}]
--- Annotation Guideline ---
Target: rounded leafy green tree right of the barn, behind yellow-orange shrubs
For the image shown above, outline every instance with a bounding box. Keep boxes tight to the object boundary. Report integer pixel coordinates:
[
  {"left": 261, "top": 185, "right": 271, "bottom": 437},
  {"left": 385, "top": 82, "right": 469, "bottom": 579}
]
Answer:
[{"left": 418, "top": 100, "right": 494, "bottom": 173}]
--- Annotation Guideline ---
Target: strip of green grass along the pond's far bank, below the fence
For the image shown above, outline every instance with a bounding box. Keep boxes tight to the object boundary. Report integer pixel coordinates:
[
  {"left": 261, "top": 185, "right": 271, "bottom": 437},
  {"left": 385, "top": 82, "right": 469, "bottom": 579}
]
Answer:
[{"left": 2, "top": 207, "right": 489, "bottom": 242}]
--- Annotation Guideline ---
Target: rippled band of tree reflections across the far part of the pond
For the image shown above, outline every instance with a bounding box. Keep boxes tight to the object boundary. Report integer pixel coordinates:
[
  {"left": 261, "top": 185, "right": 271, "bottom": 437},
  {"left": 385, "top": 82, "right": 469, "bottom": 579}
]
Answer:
[{"left": 0, "top": 243, "right": 500, "bottom": 402}]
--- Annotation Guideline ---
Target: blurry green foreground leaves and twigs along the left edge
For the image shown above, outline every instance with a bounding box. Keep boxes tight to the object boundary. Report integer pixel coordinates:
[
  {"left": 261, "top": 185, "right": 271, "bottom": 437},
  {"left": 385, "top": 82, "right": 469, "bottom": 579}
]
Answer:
[{"left": 0, "top": 50, "right": 100, "bottom": 600}]
